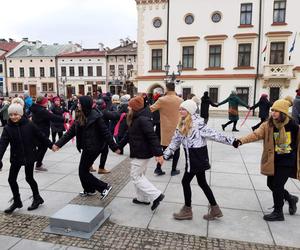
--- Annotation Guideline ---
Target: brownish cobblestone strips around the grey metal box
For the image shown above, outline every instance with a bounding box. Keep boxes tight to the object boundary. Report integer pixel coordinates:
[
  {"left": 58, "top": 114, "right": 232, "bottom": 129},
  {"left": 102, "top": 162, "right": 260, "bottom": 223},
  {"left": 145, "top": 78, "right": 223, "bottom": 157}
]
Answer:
[{"left": 0, "top": 155, "right": 296, "bottom": 249}]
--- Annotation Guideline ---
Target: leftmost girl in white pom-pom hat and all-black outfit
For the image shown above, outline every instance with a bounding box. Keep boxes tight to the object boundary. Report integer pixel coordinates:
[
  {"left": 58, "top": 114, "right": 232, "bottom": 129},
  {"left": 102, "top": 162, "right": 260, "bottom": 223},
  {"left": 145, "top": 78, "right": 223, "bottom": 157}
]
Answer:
[{"left": 0, "top": 103, "right": 52, "bottom": 214}]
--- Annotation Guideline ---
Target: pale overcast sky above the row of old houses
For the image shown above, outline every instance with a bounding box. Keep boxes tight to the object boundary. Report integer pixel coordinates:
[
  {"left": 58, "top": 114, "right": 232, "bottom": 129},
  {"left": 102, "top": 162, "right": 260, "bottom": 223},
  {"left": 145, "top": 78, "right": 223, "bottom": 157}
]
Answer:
[{"left": 0, "top": 0, "right": 137, "bottom": 48}]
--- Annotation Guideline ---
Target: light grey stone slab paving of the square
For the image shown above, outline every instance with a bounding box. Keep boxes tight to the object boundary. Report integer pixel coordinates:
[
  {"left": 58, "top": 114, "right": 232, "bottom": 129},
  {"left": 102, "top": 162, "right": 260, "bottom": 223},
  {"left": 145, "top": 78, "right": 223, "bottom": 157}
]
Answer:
[{"left": 0, "top": 118, "right": 300, "bottom": 249}]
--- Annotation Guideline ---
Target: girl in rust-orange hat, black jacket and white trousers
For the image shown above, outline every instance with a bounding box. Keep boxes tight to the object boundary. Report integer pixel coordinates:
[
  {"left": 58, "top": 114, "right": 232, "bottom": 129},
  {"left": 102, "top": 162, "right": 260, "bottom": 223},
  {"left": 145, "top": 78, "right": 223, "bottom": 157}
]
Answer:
[{"left": 119, "top": 96, "right": 164, "bottom": 210}]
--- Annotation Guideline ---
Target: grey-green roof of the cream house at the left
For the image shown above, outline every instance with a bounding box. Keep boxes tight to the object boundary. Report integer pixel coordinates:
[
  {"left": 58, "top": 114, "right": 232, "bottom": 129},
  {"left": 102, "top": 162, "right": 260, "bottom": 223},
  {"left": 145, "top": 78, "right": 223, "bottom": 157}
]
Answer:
[{"left": 9, "top": 44, "right": 75, "bottom": 58}]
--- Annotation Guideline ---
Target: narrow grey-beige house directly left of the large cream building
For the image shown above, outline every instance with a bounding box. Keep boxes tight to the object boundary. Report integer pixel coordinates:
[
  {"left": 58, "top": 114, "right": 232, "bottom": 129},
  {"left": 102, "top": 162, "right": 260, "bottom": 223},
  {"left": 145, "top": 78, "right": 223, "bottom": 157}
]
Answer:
[{"left": 107, "top": 38, "right": 137, "bottom": 96}]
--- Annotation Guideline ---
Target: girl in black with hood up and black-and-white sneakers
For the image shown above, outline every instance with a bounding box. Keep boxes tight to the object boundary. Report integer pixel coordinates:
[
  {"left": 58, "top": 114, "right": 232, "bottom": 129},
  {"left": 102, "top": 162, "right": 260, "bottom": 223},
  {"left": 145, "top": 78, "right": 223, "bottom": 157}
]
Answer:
[{"left": 54, "top": 96, "right": 120, "bottom": 199}]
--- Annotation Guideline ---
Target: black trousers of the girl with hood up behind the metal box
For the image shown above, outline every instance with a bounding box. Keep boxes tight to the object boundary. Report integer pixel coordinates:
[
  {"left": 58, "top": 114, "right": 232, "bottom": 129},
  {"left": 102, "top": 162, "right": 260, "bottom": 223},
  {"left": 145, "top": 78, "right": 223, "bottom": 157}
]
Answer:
[{"left": 79, "top": 150, "right": 107, "bottom": 192}]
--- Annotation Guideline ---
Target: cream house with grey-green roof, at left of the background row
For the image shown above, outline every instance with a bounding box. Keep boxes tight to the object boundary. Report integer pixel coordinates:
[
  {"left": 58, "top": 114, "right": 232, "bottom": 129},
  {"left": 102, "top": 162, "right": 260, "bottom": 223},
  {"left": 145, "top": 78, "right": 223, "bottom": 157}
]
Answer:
[{"left": 5, "top": 41, "right": 77, "bottom": 96}]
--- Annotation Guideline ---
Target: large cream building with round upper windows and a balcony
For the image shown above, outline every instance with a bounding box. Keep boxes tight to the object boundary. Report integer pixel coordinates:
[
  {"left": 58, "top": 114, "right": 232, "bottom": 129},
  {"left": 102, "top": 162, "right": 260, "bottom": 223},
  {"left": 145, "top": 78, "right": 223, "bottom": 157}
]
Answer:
[{"left": 136, "top": 0, "right": 300, "bottom": 109}]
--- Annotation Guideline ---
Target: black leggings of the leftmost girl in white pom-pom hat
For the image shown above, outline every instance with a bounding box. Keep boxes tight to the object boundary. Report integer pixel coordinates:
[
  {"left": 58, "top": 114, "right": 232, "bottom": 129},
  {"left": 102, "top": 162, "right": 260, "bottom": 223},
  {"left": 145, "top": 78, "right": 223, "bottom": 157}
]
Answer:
[{"left": 8, "top": 163, "right": 39, "bottom": 199}]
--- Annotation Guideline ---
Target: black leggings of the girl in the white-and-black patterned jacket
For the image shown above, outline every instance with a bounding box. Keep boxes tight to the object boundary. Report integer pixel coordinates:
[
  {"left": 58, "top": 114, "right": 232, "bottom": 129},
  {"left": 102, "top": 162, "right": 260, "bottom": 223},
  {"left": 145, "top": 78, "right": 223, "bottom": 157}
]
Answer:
[{"left": 181, "top": 171, "right": 217, "bottom": 207}]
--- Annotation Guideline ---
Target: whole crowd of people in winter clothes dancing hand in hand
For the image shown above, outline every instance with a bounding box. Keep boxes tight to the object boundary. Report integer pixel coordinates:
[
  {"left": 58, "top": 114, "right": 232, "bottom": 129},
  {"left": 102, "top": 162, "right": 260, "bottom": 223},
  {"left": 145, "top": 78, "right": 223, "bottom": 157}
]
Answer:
[{"left": 0, "top": 82, "right": 300, "bottom": 221}]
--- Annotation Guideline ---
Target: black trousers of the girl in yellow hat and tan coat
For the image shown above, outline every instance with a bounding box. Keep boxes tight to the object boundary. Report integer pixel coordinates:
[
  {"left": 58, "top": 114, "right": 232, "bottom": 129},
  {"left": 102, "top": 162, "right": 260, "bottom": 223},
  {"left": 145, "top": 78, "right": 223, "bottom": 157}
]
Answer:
[{"left": 267, "top": 166, "right": 294, "bottom": 212}]
